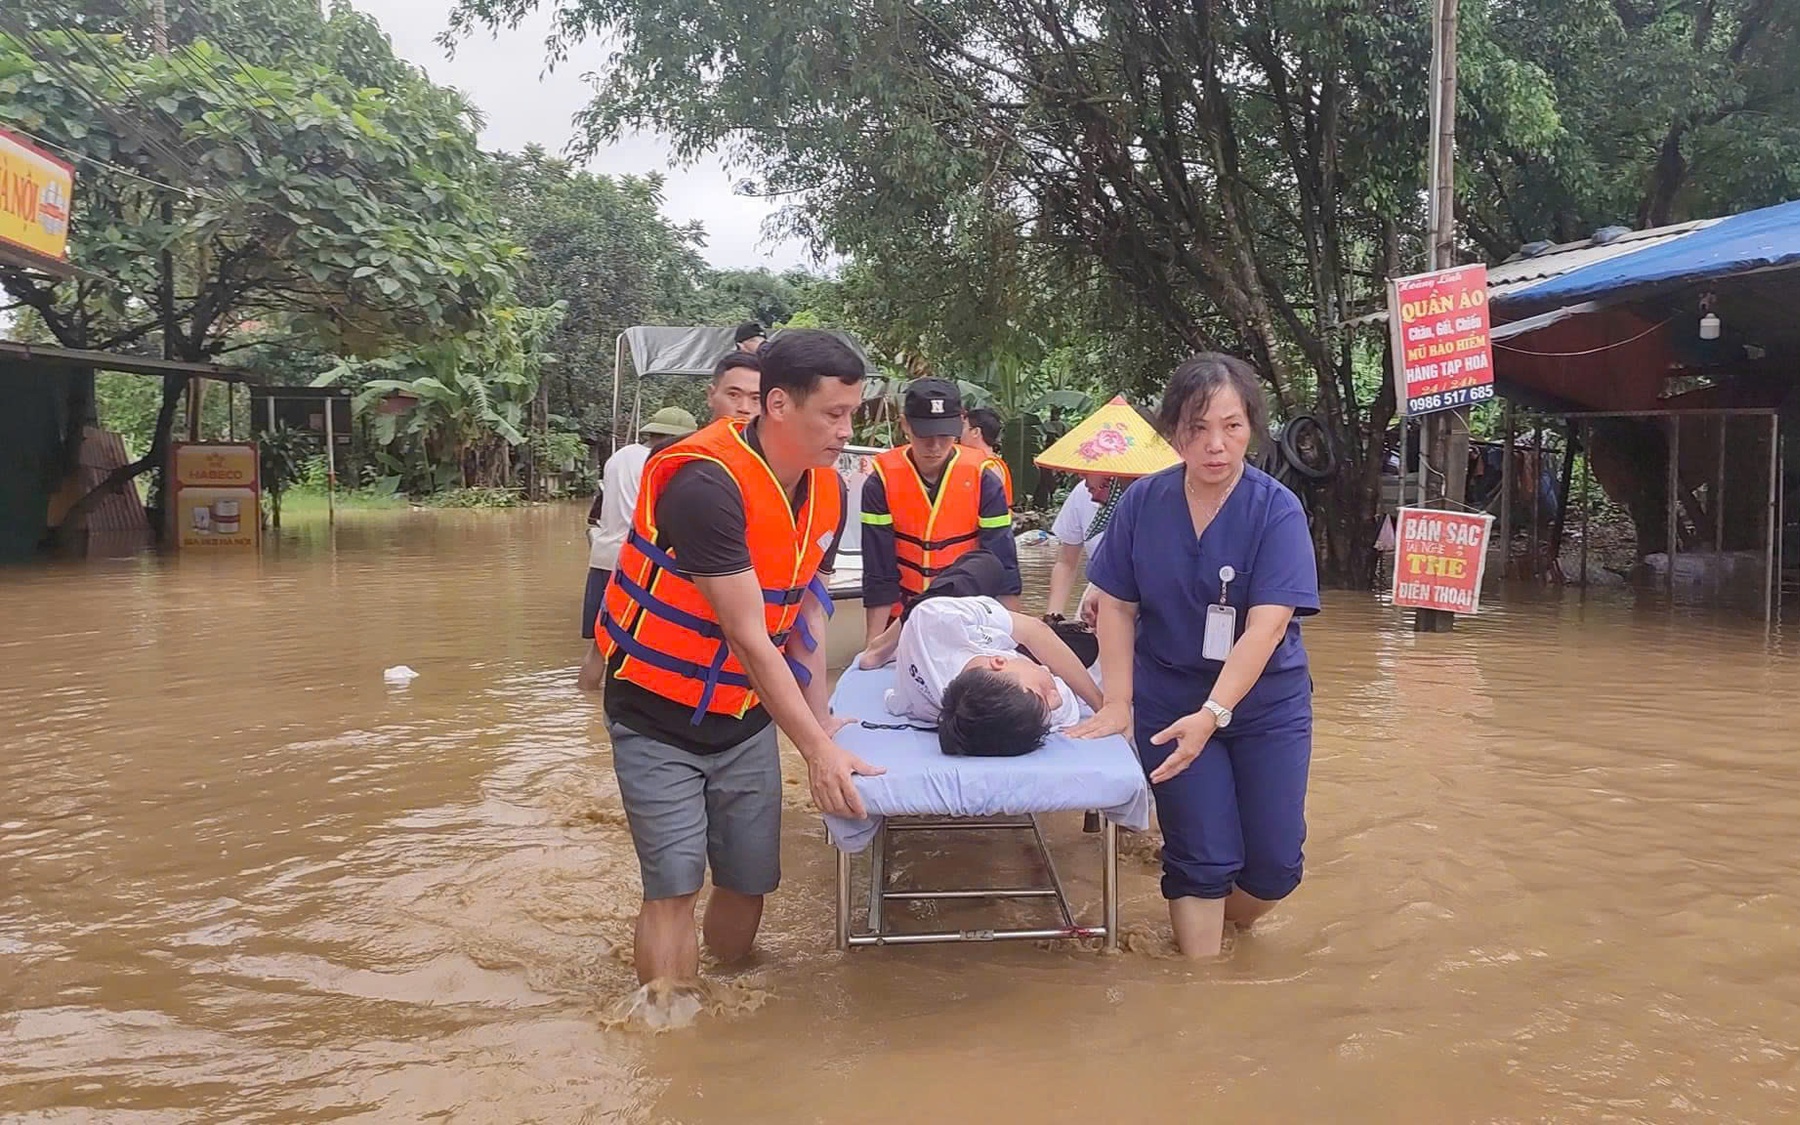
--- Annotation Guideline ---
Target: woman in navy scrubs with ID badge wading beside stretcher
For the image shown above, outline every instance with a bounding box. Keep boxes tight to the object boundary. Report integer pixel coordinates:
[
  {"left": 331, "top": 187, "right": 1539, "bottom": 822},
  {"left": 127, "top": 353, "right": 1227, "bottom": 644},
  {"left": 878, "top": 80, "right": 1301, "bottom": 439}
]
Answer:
[{"left": 1073, "top": 353, "right": 1319, "bottom": 958}]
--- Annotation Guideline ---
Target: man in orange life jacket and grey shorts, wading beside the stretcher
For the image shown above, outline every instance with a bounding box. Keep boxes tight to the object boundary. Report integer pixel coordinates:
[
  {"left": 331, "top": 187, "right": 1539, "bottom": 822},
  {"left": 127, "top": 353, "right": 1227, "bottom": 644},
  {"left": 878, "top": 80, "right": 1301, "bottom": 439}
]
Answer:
[{"left": 579, "top": 329, "right": 880, "bottom": 983}]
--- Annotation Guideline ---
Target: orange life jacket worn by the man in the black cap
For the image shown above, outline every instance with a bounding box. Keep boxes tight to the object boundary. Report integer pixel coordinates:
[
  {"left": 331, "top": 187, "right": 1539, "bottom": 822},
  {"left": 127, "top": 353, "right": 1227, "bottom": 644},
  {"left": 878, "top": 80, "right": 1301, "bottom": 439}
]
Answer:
[{"left": 875, "top": 445, "right": 981, "bottom": 598}]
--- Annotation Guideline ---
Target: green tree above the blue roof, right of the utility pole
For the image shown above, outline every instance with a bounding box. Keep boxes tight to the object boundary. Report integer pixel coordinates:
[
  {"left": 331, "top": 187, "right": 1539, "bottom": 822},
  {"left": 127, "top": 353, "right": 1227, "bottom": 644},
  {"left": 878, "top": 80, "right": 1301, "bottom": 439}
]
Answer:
[{"left": 1458, "top": 0, "right": 1800, "bottom": 259}]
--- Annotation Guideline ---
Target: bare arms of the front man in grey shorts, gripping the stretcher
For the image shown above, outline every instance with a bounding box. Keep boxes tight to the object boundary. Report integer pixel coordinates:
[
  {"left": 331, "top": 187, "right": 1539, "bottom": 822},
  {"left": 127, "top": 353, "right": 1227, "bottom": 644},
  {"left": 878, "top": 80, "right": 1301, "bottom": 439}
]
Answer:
[{"left": 693, "top": 571, "right": 887, "bottom": 819}]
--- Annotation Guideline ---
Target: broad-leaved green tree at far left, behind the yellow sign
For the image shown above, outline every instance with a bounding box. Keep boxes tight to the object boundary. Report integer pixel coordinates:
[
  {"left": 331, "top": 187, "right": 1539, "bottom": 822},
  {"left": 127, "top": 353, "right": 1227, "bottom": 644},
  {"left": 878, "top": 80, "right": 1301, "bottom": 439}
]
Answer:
[{"left": 0, "top": 0, "right": 518, "bottom": 529}]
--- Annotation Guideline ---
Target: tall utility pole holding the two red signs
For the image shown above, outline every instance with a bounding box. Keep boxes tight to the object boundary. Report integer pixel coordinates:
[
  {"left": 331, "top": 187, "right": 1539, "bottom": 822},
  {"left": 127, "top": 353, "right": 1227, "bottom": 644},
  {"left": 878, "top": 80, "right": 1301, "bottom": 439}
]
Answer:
[{"left": 1400, "top": 0, "right": 1469, "bottom": 634}]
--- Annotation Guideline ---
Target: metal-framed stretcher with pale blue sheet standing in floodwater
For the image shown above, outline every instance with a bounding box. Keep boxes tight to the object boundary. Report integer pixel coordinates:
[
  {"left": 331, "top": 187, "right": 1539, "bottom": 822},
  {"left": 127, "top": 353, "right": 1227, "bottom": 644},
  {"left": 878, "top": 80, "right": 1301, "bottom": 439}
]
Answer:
[{"left": 824, "top": 666, "right": 1150, "bottom": 949}]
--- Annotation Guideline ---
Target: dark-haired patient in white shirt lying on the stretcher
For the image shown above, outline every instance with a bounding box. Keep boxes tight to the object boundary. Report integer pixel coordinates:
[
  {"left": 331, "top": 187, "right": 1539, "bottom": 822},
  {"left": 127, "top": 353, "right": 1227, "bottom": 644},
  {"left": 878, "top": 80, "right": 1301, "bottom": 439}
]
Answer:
[{"left": 859, "top": 551, "right": 1100, "bottom": 758}]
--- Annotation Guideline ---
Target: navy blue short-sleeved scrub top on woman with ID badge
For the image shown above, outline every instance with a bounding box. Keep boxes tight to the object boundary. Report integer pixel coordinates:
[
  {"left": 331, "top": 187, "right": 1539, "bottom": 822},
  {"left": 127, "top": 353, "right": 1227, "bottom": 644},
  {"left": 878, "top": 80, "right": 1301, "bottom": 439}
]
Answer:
[{"left": 1087, "top": 464, "right": 1319, "bottom": 729}]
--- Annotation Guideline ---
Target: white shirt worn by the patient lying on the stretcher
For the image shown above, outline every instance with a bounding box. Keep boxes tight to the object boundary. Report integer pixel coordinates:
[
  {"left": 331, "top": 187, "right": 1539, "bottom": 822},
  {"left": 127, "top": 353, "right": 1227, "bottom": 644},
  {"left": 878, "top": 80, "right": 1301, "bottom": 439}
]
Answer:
[{"left": 884, "top": 598, "right": 1082, "bottom": 731}]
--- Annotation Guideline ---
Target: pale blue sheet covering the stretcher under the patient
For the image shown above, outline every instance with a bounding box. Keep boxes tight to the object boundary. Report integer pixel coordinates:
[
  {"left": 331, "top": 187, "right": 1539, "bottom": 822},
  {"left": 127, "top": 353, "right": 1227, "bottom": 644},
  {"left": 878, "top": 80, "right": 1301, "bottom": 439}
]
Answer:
[{"left": 824, "top": 666, "right": 1150, "bottom": 851}]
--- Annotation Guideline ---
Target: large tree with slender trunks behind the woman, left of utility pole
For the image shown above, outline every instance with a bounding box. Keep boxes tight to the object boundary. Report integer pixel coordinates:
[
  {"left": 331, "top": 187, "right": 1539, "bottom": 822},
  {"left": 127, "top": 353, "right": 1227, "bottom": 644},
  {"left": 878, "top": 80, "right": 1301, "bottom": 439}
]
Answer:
[{"left": 439, "top": 0, "right": 1447, "bottom": 580}]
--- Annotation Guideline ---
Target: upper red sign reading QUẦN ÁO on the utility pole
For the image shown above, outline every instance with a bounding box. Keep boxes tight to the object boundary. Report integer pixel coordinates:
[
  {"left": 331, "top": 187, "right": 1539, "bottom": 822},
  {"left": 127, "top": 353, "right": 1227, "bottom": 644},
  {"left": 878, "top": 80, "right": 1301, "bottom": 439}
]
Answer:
[{"left": 1388, "top": 266, "right": 1494, "bottom": 414}]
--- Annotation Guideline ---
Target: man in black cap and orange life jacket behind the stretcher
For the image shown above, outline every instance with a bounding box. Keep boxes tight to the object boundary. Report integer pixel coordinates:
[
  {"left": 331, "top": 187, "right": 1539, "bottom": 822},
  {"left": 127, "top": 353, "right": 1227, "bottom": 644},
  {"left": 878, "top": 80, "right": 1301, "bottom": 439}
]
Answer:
[{"left": 862, "top": 378, "right": 1019, "bottom": 646}]
